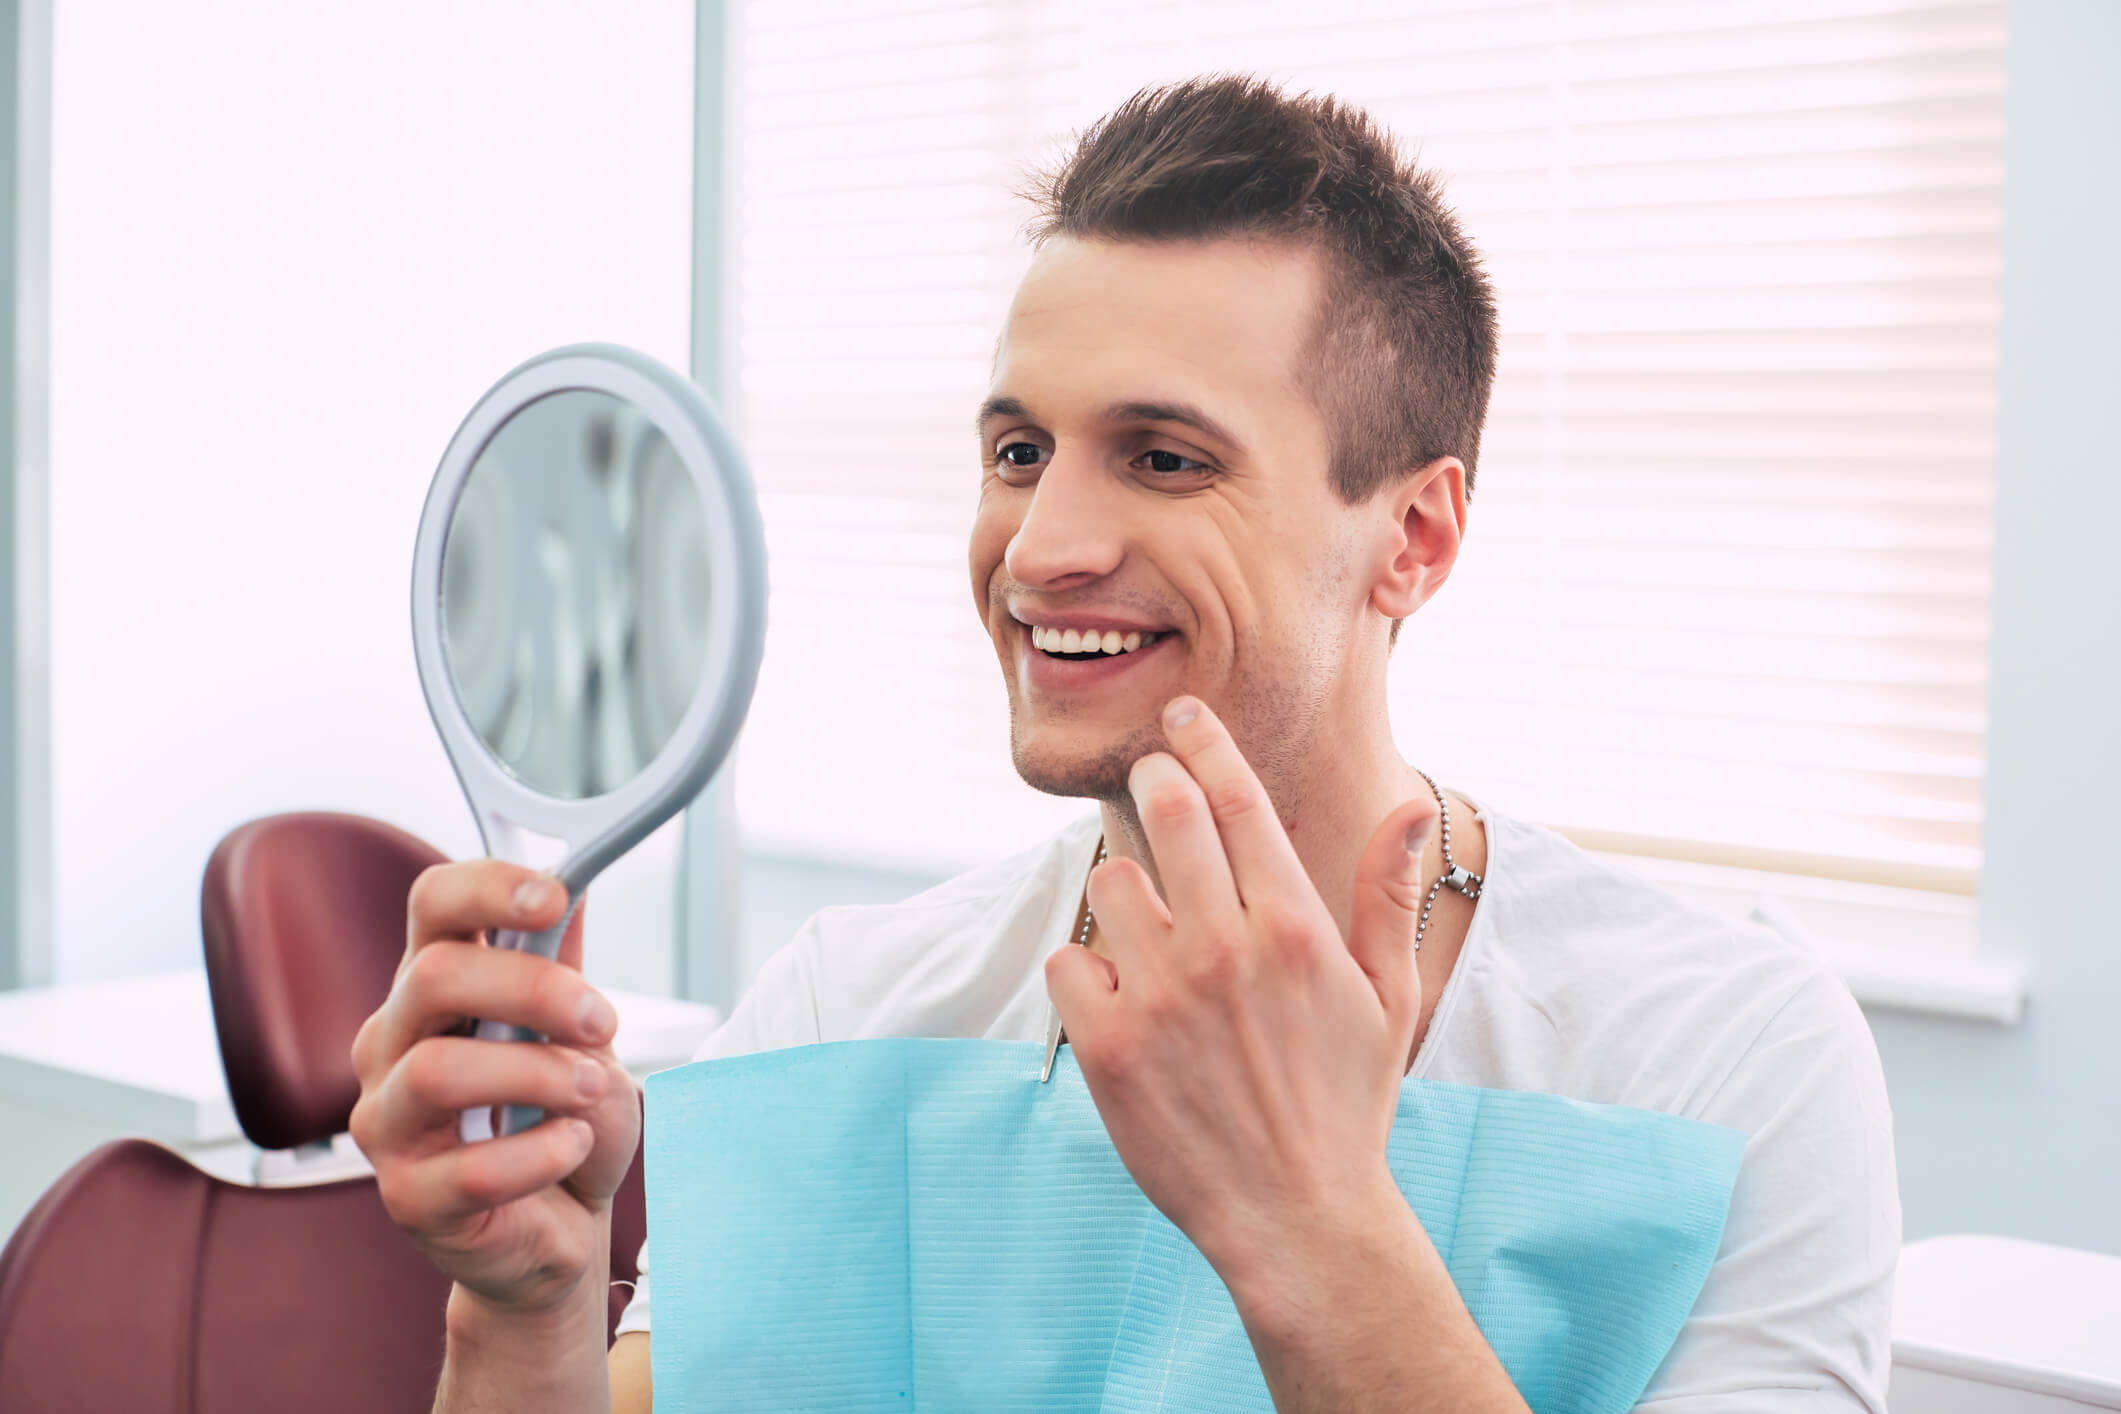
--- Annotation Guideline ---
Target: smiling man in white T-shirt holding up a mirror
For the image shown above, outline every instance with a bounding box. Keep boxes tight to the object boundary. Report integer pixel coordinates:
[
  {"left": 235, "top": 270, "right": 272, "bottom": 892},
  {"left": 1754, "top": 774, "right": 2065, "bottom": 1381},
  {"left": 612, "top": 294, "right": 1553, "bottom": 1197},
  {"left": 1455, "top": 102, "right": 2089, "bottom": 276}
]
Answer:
[{"left": 354, "top": 78, "right": 1898, "bottom": 1414}]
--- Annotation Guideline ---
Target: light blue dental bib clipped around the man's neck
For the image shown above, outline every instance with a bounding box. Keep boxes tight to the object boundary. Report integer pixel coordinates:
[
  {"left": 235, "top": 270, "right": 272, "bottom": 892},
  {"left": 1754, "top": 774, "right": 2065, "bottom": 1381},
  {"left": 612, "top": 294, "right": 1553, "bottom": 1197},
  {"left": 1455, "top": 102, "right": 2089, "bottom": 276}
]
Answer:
[{"left": 645, "top": 1041, "right": 1746, "bottom": 1414}]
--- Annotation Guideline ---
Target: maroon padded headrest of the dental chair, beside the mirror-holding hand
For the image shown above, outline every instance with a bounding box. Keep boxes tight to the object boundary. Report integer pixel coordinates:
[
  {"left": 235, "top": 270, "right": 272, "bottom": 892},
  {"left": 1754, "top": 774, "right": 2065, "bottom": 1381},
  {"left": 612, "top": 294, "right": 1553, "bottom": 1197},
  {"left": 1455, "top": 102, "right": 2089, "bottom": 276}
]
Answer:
[{"left": 199, "top": 812, "right": 443, "bottom": 1149}]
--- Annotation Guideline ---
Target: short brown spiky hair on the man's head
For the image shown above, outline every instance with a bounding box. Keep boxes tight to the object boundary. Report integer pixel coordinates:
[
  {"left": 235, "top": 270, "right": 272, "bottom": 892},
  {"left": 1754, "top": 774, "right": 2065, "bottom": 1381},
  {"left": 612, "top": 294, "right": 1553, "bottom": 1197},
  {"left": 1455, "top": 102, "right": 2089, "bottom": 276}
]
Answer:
[{"left": 1024, "top": 76, "right": 1495, "bottom": 505}]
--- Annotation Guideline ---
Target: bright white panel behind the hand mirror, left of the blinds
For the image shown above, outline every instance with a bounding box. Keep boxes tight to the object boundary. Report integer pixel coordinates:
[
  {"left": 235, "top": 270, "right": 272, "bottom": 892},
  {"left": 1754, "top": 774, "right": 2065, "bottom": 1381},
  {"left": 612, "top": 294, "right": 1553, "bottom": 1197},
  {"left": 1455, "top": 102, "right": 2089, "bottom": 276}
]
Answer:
[{"left": 51, "top": 0, "right": 694, "bottom": 990}]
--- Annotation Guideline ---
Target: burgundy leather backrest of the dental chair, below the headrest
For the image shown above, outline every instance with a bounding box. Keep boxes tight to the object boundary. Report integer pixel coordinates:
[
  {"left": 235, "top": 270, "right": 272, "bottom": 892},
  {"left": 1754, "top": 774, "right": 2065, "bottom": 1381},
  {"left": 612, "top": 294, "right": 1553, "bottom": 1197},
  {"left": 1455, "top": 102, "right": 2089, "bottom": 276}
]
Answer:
[{"left": 0, "top": 1138, "right": 450, "bottom": 1414}]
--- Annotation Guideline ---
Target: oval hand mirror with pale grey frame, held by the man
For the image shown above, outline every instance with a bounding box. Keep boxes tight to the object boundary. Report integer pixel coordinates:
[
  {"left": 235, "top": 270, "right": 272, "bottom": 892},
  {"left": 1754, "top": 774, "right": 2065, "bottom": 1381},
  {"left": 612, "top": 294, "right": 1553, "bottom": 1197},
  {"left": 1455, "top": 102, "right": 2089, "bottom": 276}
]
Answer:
[{"left": 411, "top": 343, "right": 766, "bottom": 1138}]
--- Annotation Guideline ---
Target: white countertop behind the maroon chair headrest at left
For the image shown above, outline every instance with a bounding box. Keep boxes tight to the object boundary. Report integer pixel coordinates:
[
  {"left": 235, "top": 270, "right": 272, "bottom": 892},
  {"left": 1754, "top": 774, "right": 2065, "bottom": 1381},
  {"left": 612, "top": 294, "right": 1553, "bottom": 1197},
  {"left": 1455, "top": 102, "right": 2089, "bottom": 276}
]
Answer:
[{"left": 0, "top": 967, "right": 721, "bottom": 1149}]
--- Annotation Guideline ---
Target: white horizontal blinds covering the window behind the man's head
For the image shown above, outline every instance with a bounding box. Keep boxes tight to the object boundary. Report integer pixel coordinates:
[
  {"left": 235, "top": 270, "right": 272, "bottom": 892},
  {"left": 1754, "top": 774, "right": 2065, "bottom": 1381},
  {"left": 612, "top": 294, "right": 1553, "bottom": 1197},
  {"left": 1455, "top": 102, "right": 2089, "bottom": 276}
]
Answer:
[{"left": 721, "top": 0, "right": 2004, "bottom": 888}]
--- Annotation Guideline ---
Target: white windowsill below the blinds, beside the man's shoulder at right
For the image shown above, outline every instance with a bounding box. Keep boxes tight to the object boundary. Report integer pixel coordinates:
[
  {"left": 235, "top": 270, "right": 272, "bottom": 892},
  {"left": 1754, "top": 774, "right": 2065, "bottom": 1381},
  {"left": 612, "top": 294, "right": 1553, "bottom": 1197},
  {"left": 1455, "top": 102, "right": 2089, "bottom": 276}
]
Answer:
[{"left": 1599, "top": 854, "right": 2026, "bottom": 1026}]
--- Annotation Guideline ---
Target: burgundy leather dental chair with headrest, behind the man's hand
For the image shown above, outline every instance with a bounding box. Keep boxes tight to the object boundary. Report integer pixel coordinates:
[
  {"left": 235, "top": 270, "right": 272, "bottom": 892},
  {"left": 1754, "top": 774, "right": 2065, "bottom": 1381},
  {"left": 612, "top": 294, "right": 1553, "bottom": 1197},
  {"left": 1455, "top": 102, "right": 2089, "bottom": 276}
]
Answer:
[{"left": 0, "top": 814, "right": 647, "bottom": 1414}]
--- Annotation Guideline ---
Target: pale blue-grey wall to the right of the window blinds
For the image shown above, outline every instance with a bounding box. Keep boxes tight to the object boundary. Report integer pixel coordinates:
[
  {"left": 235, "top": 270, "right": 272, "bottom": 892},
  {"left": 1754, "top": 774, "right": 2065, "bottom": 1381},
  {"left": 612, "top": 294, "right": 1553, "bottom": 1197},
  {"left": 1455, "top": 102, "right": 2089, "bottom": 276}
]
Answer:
[{"left": 1871, "top": 0, "right": 2121, "bottom": 1253}]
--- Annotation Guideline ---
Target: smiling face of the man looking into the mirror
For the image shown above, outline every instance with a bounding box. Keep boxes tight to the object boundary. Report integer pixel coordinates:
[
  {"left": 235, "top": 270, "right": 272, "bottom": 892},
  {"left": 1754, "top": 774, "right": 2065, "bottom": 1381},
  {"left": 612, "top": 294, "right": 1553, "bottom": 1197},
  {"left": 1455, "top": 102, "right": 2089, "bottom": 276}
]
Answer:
[{"left": 971, "top": 240, "right": 1374, "bottom": 816}]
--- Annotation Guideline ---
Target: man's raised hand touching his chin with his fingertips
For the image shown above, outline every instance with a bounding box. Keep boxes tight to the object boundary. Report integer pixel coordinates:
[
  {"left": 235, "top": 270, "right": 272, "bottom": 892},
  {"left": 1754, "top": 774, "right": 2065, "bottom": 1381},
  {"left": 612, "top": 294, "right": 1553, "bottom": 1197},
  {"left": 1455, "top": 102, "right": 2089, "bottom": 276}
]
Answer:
[{"left": 1046, "top": 697, "right": 1438, "bottom": 1287}]
